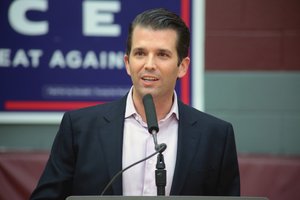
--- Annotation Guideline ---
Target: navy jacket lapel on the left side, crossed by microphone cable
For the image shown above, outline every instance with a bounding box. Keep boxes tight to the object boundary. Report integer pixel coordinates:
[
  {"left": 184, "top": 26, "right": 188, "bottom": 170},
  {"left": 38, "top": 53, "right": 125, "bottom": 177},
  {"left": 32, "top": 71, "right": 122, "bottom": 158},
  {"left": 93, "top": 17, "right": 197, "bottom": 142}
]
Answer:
[{"left": 99, "top": 96, "right": 127, "bottom": 195}]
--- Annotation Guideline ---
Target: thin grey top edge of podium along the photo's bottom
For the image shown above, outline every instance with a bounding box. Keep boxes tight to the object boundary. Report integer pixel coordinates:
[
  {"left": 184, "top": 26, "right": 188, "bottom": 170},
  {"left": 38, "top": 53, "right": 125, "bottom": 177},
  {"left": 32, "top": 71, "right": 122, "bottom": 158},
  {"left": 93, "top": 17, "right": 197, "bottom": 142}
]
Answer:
[{"left": 66, "top": 196, "right": 268, "bottom": 200}]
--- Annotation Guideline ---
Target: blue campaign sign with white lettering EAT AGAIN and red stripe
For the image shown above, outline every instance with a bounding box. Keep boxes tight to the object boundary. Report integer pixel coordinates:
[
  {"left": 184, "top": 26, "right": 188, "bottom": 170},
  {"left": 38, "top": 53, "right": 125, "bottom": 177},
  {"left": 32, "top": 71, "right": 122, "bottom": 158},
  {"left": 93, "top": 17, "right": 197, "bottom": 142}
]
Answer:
[{"left": 0, "top": 0, "right": 189, "bottom": 115}]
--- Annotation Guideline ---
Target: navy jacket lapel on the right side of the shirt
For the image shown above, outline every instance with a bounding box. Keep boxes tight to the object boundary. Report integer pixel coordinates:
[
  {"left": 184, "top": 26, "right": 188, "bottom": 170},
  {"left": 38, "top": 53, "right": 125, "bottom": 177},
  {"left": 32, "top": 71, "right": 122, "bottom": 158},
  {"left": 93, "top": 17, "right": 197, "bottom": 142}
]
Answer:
[{"left": 170, "top": 101, "right": 200, "bottom": 195}]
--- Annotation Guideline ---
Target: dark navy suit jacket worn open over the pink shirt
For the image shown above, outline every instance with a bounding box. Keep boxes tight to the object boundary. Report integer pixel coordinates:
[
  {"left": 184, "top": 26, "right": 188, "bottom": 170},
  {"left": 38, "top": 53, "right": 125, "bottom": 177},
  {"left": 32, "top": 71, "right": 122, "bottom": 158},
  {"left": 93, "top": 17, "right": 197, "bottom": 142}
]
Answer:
[{"left": 31, "top": 96, "right": 240, "bottom": 200}]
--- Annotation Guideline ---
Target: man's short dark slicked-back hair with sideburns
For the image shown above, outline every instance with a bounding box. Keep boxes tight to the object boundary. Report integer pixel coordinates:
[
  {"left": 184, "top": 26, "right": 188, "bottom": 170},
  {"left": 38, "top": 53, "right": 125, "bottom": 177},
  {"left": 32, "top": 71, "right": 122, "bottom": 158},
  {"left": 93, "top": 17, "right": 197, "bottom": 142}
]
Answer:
[{"left": 126, "top": 8, "right": 190, "bottom": 64}]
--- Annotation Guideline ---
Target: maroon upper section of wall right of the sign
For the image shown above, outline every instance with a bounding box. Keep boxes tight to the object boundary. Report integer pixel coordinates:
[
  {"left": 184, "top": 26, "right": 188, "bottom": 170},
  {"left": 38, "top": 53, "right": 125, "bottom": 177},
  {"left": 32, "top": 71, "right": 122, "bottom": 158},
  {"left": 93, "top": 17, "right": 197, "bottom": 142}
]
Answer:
[{"left": 205, "top": 0, "right": 300, "bottom": 70}]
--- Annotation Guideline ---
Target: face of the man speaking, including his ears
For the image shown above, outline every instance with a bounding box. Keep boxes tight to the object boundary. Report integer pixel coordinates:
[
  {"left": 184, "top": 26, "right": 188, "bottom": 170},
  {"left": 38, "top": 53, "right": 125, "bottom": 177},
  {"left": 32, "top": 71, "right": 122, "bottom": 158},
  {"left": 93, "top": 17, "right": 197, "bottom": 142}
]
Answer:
[{"left": 124, "top": 26, "right": 189, "bottom": 99}]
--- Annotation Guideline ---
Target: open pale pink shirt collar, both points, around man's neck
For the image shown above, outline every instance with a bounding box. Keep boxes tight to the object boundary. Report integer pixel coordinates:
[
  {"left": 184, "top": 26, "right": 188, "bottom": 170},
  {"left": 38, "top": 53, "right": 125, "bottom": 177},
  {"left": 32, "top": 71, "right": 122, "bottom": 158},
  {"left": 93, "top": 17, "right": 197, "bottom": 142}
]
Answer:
[{"left": 125, "top": 86, "right": 179, "bottom": 121}]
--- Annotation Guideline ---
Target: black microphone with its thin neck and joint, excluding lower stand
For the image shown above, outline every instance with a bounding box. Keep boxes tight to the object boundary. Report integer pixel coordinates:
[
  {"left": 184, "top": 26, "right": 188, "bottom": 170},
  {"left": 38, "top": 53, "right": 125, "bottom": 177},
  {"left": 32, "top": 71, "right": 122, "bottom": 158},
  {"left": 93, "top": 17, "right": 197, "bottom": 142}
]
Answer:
[{"left": 143, "top": 94, "right": 167, "bottom": 153}]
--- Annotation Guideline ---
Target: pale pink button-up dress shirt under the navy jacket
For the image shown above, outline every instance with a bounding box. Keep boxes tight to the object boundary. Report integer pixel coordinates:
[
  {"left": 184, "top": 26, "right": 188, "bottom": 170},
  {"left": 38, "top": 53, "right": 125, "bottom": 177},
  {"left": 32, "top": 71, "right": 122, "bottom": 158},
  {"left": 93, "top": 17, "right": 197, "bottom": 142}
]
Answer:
[{"left": 122, "top": 88, "right": 179, "bottom": 196}]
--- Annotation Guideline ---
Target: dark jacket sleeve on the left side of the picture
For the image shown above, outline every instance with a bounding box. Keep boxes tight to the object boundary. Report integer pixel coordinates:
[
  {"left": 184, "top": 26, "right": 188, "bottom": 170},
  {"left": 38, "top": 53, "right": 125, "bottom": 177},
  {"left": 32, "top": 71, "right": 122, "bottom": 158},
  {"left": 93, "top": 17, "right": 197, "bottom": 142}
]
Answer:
[{"left": 30, "top": 113, "right": 75, "bottom": 200}]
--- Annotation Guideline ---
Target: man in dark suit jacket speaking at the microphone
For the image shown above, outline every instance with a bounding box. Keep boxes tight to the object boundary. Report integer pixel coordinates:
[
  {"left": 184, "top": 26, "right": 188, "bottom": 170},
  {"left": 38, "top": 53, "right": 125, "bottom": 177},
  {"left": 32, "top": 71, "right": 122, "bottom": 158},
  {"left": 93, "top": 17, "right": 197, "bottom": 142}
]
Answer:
[{"left": 31, "top": 9, "right": 240, "bottom": 199}]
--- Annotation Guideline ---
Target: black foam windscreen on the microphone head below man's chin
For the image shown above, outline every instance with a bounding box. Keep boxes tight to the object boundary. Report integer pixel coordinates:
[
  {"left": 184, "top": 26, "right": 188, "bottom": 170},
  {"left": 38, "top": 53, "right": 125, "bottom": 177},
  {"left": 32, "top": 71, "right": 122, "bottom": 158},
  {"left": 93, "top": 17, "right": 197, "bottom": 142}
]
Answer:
[{"left": 143, "top": 94, "right": 159, "bottom": 134}]
